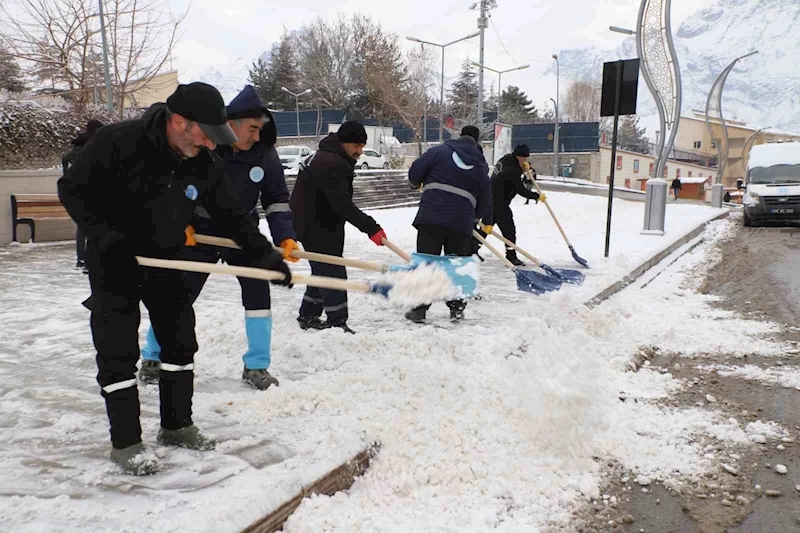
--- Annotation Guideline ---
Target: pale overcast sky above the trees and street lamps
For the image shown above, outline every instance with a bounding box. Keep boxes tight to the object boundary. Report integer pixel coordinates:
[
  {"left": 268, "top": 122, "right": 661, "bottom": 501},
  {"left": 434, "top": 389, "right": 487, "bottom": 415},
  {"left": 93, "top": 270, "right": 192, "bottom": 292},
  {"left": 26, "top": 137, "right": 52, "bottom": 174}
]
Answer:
[{"left": 170, "top": 0, "right": 713, "bottom": 107}]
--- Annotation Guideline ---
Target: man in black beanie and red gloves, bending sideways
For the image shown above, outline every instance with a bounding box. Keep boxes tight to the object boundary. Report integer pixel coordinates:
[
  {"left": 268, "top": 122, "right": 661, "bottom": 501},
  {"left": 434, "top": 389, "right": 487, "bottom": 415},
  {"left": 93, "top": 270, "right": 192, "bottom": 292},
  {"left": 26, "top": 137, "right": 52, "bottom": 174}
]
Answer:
[{"left": 291, "top": 122, "right": 386, "bottom": 333}]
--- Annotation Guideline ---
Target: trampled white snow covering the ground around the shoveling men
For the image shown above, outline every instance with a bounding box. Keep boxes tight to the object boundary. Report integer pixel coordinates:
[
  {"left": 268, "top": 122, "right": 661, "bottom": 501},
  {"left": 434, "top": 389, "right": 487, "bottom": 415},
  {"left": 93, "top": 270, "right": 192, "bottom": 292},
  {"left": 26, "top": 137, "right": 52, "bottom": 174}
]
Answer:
[{"left": 0, "top": 193, "right": 780, "bottom": 533}]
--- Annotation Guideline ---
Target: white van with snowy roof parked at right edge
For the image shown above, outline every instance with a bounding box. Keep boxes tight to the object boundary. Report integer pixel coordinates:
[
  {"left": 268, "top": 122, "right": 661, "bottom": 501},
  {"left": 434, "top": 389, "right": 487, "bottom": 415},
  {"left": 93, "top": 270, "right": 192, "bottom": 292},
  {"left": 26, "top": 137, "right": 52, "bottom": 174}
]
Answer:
[{"left": 739, "top": 143, "right": 800, "bottom": 226}]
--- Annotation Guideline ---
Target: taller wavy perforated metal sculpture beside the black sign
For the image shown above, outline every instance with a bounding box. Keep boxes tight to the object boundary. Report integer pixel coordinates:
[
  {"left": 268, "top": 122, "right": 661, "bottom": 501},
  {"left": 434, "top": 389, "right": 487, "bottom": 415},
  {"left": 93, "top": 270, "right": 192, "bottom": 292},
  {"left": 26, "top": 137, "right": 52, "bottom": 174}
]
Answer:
[{"left": 636, "top": 0, "right": 682, "bottom": 178}]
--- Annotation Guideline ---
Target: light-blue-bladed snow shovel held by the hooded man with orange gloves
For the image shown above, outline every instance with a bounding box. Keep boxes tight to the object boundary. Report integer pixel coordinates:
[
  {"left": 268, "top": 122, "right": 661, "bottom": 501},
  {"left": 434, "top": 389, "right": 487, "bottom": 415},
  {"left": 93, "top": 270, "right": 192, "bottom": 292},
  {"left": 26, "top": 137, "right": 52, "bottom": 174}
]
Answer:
[{"left": 192, "top": 233, "right": 480, "bottom": 298}]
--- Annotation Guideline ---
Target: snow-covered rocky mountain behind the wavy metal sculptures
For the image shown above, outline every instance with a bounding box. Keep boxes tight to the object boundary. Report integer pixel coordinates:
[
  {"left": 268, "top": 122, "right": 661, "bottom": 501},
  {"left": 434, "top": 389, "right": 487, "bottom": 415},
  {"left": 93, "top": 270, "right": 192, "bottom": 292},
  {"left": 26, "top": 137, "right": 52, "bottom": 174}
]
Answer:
[{"left": 553, "top": 0, "right": 800, "bottom": 136}]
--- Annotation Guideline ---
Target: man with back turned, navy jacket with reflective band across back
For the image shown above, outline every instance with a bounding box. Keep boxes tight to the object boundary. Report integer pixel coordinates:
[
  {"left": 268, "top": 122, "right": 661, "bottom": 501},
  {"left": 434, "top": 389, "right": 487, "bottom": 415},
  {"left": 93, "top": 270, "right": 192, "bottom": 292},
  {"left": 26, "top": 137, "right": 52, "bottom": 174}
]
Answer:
[{"left": 406, "top": 126, "right": 492, "bottom": 323}]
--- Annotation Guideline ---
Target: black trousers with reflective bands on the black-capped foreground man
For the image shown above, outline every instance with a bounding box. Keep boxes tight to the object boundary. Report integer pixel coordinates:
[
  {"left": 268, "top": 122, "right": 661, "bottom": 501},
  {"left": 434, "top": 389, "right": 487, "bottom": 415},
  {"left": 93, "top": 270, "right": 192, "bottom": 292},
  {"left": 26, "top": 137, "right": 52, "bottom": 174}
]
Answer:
[{"left": 84, "top": 239, "right": 197, "bottom": 448}]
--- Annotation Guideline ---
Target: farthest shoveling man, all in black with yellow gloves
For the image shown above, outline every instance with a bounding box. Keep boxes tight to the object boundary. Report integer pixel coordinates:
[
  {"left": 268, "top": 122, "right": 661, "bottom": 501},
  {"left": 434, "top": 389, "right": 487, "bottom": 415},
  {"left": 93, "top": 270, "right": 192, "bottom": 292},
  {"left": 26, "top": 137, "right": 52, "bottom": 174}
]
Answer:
[{"left": 488, "top": 144, "right": 546, "bottom": 266}]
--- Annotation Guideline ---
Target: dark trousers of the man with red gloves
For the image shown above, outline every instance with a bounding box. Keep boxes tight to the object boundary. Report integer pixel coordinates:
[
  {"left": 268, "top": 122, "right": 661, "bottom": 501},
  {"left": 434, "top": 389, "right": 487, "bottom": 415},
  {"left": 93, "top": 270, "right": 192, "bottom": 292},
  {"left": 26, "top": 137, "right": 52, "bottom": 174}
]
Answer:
[{"left": 299, "top": 227, "right": 350, "bottom": 324}]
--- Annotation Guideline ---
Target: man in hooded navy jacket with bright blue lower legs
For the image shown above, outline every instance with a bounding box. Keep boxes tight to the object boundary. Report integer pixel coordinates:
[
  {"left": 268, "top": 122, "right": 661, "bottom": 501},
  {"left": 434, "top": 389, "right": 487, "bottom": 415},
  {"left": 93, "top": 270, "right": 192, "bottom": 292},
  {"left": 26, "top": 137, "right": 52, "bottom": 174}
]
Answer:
[{"left": 139, "top": 85, "right": 299, "bottom": 390}]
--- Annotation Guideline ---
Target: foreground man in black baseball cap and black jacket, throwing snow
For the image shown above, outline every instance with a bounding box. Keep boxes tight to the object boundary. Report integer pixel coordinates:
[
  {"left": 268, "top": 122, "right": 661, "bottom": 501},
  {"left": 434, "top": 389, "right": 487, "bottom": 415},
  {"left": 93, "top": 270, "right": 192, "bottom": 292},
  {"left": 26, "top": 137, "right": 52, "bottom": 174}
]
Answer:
[{"left": 58, "top": 83, "right": 291, "bottom": 475}]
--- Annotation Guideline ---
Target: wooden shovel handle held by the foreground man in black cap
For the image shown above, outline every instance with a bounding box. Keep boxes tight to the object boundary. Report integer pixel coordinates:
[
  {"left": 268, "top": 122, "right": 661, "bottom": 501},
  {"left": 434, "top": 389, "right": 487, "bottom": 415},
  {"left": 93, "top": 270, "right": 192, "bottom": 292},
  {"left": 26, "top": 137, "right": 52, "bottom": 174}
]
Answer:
[{"left": 136, "top": 256, "right": 370, "bottom": 293}]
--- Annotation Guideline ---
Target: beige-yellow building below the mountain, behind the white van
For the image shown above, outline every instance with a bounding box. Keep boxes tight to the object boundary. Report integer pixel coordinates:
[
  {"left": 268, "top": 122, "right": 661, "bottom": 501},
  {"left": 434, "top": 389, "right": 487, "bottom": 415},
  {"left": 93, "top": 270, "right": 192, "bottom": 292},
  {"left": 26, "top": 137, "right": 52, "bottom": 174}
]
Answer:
[{"left": 675, "top": 111, "right": 800, "bottom": 190}]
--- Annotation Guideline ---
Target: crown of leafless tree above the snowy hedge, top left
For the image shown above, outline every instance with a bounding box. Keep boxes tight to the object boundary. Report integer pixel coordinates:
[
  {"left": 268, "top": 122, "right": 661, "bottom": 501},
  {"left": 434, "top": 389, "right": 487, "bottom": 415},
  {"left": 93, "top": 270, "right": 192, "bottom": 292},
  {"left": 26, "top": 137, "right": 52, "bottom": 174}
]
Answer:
[{"left": 0, "top": 0, "right": 186, "bottom": 113}]
